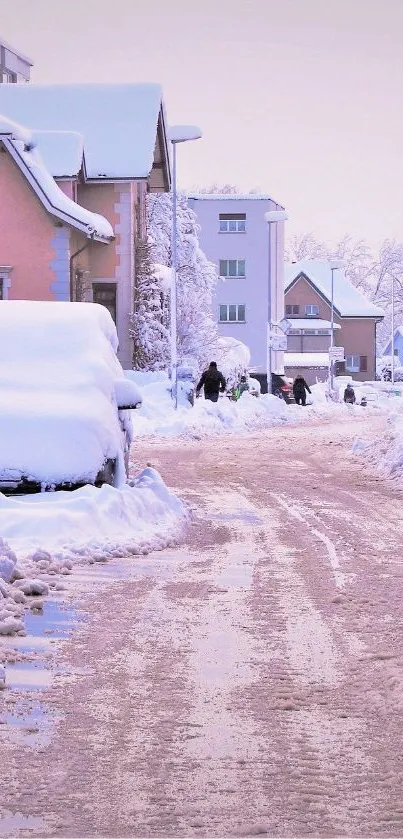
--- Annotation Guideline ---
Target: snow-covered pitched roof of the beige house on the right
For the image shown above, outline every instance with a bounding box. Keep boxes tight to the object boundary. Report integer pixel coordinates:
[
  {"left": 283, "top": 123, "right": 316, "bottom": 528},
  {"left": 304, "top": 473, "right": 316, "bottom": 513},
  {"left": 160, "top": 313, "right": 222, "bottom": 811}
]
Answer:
[{"left": 284, "top": 259, "right": 384, "bottom": 318}]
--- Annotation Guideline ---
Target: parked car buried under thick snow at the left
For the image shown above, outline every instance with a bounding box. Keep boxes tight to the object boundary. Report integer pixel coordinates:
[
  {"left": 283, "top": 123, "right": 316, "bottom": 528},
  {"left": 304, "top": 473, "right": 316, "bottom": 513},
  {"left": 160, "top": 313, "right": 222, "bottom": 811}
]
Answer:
[{"left": 0, "top": 300, "right": 141, "bottom": 493}]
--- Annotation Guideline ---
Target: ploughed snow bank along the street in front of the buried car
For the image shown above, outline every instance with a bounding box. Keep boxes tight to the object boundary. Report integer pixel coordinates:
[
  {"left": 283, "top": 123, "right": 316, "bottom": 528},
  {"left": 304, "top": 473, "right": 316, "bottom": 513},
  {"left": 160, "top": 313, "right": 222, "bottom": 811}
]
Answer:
[{"left": 0, "top": 467, "right": 189, "bottom": 635}]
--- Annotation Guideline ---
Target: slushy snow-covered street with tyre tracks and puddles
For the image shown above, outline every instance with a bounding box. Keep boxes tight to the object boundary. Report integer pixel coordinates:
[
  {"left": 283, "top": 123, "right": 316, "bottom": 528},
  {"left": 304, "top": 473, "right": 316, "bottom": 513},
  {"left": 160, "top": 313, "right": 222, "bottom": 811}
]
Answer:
[{"left": 0, "top": 414, "right": 403, "bottom": 837}]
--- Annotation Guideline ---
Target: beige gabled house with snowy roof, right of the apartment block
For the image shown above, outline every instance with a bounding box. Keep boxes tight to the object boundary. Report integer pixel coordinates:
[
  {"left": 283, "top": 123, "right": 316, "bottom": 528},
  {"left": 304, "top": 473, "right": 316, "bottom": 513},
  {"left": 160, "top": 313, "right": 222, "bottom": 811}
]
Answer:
[{"left": 284, "top": 259, "right": 384, "bottom": 384}]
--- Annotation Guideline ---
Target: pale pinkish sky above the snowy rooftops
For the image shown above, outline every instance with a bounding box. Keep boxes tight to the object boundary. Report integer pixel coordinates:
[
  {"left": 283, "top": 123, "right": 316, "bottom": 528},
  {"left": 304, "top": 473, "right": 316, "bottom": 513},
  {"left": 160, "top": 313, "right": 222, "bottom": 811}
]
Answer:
[{"left": 0, "top": 0, "right": 403, "bottom": 247}]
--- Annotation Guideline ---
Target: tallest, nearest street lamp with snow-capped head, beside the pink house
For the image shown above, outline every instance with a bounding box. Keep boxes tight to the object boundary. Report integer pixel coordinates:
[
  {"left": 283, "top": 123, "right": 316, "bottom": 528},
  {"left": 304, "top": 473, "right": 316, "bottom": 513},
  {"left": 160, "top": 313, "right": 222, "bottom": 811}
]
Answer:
[{"left": 168, "top": 125, "right": 203, "bottom": 408}]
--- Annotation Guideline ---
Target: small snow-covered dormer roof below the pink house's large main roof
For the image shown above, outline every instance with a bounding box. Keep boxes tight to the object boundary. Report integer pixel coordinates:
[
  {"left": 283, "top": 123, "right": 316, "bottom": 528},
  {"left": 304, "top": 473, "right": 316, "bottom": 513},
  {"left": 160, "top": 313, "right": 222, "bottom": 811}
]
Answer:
[{"left": 32, "top": 131, "right": 84, "bottom": 178}]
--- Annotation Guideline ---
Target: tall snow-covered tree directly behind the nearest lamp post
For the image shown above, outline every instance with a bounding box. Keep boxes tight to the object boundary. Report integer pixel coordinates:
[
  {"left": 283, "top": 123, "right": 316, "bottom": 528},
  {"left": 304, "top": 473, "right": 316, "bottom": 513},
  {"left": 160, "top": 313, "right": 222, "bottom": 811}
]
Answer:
[{"left": 147, "top": 193, "right": 218, "bottom": 372}]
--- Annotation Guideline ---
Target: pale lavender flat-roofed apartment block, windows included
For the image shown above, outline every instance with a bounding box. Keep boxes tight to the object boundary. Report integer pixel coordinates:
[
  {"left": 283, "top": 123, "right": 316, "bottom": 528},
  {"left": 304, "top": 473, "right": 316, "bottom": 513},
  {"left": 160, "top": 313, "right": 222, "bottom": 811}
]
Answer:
[{"left": 188, "top": 193, "right": 284, "bottom": 389}]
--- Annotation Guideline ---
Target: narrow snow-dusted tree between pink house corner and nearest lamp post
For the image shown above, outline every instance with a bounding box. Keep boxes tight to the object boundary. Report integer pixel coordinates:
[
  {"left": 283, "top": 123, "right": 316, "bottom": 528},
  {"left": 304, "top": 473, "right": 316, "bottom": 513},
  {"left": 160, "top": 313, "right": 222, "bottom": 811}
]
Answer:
[{"left": 130, "top": 240, "right": 169, "bottom": 370}]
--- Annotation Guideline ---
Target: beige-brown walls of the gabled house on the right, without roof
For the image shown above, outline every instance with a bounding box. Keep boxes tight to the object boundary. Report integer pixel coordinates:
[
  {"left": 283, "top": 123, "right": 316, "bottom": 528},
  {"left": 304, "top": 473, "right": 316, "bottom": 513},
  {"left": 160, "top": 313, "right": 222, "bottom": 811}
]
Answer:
[{"left": 285, "top": 277, "right": 376, "bottom": 381}]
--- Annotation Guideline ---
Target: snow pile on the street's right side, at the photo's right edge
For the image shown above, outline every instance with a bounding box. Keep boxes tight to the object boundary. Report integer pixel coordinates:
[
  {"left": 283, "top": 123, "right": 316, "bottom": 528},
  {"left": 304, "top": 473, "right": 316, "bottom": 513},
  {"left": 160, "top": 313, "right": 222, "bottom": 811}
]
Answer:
[{"left": 353, "top": 413, "right": 403, "bottom": 484}]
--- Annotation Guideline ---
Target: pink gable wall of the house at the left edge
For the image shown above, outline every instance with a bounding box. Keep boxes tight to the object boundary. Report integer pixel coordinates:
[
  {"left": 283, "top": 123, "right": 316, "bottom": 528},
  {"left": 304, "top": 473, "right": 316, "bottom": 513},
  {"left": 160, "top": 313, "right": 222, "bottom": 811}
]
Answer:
[{"left": 0, "top": 151, "right": 64, "bottom": 300}]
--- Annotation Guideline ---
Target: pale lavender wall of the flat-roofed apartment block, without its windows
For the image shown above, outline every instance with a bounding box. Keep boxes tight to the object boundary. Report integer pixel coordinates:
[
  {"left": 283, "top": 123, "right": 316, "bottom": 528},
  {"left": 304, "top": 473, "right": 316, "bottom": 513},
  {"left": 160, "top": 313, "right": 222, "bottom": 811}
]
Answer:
[{"left": 189, "top": 197, "right": 284, "bottom": 373}]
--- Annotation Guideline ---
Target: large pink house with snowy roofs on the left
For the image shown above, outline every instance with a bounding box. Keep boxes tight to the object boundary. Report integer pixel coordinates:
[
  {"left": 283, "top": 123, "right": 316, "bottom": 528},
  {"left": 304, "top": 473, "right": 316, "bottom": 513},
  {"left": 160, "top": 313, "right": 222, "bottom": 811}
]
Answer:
[{"left": 0, "top": 84, "right": 170, "bottom": 367}]
